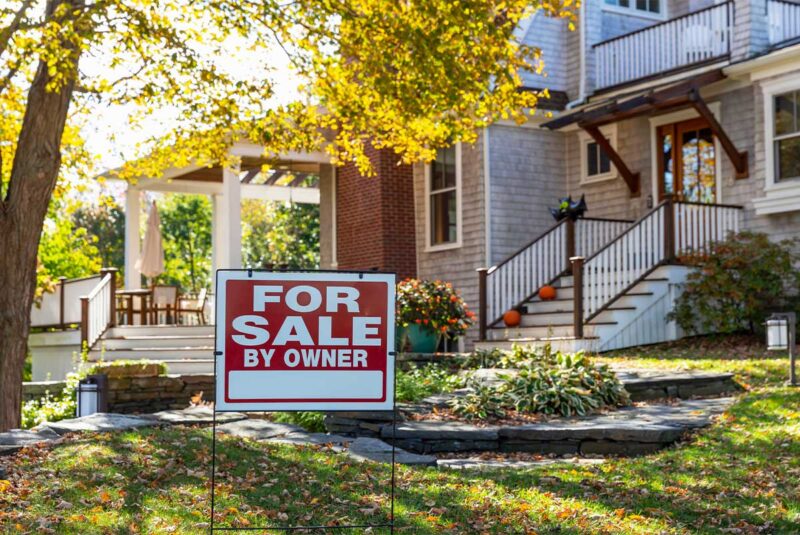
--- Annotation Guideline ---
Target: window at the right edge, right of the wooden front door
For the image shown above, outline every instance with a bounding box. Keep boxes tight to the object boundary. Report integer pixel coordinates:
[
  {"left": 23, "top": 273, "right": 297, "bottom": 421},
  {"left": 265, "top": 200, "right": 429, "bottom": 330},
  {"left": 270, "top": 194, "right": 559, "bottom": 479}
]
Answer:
[{"left": 772, "top": 91, "right": 800, "bottom": 182}]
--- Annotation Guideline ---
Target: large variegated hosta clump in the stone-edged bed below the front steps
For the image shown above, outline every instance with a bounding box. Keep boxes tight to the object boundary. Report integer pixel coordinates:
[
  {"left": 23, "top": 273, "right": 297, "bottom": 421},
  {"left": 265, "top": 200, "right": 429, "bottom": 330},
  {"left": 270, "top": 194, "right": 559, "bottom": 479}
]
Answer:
[{"left": 451, "top": 346, "right": 629, "bottom": 419}]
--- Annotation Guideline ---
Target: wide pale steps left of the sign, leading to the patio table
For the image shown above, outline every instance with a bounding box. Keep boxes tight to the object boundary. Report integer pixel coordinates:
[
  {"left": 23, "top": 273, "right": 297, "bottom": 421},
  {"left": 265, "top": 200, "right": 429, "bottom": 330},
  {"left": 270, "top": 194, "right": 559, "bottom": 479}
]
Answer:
[{"left": 89, "top": 325, "right": 214, "bottom": 375}]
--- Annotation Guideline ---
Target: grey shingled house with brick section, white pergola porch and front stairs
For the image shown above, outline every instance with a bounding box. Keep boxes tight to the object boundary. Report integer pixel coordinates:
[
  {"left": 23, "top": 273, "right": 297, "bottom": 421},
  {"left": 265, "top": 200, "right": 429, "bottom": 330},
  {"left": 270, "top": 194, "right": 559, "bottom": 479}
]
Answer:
[{"left": 31, "top": 0, "right": 800, "bottom": 376}]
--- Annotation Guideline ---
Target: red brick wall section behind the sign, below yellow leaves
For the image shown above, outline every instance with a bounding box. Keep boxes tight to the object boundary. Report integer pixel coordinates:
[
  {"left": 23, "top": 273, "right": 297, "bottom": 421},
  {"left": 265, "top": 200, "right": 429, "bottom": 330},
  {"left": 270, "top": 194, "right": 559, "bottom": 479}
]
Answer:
[{"left": 336, "top": 148, "right": 417, "bottom": 278}]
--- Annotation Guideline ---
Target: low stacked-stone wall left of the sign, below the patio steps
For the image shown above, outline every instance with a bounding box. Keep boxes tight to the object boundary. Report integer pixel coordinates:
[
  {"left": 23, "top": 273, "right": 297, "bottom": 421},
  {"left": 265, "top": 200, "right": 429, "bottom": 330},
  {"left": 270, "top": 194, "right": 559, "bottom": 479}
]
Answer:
[{"left": 23, "top": 374, "right": 214, "bottom": 414}]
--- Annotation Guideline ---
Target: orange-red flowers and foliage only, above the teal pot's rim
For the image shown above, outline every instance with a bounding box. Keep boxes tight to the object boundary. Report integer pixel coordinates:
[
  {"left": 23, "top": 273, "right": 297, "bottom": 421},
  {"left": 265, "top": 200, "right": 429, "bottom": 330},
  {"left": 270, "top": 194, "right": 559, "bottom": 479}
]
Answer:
[{"left": 397, "top": 279, "right": 475, "bottom": 338}]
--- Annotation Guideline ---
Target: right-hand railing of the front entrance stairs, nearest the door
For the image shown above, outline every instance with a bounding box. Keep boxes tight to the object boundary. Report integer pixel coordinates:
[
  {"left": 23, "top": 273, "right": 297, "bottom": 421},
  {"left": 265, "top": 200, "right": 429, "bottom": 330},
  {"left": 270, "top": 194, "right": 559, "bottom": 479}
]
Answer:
[{"left": 573, "top": 200, "right": 741, "bottom": 326}]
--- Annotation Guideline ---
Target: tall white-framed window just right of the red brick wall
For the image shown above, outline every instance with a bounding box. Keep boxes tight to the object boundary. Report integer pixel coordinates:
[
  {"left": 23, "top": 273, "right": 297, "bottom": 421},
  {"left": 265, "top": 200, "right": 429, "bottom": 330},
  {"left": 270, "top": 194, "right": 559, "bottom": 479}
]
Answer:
[{"left": 426, "top": 146, "right": 461, "bottom": 249}]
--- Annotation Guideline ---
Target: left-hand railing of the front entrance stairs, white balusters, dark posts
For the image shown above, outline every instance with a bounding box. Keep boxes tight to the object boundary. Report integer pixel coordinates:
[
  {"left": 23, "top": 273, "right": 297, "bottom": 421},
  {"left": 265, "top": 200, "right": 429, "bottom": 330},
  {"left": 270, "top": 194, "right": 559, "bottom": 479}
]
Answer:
[{"left": 478, "top": 218, "right": 632, "bottom": 339}]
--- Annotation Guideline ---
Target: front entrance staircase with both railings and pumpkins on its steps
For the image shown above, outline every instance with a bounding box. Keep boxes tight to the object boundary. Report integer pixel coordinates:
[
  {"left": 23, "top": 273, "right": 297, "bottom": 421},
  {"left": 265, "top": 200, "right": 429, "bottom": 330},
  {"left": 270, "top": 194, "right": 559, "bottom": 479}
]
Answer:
[{"left": 476, "top": 200, "right": 741, "bottom": 352}]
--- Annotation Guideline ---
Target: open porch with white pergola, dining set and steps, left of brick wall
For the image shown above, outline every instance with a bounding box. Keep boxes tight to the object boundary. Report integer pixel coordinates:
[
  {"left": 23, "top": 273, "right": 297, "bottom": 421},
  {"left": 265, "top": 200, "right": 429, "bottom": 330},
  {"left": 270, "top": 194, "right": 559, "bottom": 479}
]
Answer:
[{"left": 29, "top": 142, "right": 334, "bottom": 380}]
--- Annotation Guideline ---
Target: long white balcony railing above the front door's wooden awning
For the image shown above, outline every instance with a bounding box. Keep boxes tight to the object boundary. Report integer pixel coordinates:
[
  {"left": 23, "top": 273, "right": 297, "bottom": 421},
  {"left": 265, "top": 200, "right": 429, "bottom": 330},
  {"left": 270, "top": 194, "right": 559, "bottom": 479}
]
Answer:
[{"left": 594, "top": 0, "right": 732, "bottom": 89}]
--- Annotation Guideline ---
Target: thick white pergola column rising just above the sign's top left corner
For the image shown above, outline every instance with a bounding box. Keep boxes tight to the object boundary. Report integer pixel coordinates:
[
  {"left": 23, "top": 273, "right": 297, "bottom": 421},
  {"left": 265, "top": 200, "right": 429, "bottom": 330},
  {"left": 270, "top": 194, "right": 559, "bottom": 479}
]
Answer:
[{"left": 214, "top": 168, "right": 242, "bottom": 269}]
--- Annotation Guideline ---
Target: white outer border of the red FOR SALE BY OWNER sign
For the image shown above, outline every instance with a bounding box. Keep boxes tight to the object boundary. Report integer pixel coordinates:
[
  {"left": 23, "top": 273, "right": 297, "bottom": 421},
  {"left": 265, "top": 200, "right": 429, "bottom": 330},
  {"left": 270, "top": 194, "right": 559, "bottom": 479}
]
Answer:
[{"left": 214, "top": 269, "right": 397, "bottom": 412}]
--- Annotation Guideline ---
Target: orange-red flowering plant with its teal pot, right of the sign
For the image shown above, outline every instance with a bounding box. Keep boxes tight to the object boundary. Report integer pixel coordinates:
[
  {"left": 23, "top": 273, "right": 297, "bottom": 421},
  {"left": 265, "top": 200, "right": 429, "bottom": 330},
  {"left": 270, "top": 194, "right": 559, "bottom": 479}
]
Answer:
[{"left": 397, "top": 279, "right": 475, "bottom": 353}]
